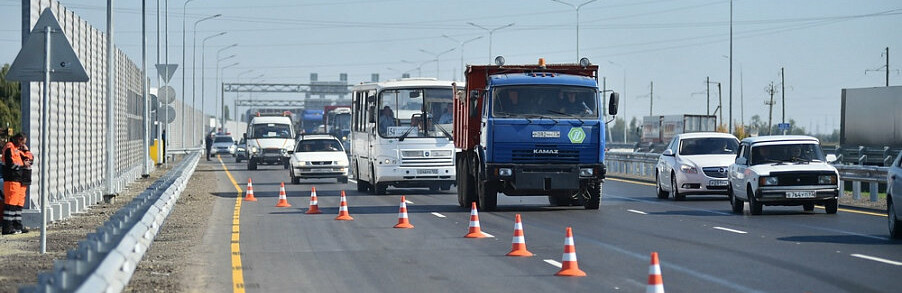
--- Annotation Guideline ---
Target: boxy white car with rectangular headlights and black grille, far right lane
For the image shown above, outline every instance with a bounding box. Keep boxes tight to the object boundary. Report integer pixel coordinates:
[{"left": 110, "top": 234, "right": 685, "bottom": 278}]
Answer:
[{"left": 729, "top": 136, "right": 839, "bottom": 215}]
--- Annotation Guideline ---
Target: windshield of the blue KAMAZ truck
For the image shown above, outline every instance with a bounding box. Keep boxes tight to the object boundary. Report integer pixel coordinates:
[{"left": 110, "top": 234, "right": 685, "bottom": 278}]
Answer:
[{"left": 492, "top": 85, "right": 598, "bottom": 118}]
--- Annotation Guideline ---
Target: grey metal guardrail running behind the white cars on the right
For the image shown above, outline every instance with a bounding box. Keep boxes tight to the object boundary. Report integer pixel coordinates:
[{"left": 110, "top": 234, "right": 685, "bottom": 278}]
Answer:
[{"left": 605, "top": 152, "right": 889, "bottom": 202}]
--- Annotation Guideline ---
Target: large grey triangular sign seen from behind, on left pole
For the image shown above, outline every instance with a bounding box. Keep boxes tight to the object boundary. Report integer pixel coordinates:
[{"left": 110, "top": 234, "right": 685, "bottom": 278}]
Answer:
[{"left": 6, "top": 9, "right": 88, "bottom": 82}]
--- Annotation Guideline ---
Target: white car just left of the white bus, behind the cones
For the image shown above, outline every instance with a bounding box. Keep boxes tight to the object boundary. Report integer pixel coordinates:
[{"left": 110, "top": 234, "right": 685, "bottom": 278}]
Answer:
[{"left": 288, "top": 135, "right": 349, "bottom": 184}]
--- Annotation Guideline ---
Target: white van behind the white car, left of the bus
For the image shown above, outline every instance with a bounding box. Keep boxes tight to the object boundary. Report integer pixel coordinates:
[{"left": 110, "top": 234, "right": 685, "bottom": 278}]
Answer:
[{"left": 244, "top": 112, "right": 295, "bottom": 170}]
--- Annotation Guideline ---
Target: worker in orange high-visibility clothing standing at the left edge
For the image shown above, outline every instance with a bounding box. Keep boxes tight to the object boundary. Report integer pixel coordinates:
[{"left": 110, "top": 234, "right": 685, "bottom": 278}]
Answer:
[{"left": 2, "top": 133, "right": 34, "bottom": 234}]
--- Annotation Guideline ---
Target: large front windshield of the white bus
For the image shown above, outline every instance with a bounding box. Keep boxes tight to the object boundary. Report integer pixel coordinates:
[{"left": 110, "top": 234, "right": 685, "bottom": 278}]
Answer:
[{"left": 376, "top": 87, "right": 453, "bottom": 138}]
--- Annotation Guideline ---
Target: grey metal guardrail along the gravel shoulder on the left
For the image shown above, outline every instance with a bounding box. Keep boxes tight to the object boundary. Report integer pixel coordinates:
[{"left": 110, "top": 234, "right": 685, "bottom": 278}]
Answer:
[{"left": 19, "top": 152, "right": 200, "bottom": 292}]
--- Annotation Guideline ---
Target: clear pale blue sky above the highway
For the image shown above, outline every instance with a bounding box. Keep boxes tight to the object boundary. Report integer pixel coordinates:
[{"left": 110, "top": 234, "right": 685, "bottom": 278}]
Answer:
[{"left": 0, "top": 0, "right": 902, "bottom": 133}]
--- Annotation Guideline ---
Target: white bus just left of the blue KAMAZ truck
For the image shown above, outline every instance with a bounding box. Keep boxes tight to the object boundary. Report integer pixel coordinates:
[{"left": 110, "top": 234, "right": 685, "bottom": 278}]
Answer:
[{"left": 351, "top": 78, "right": 456, "bottom": 194}]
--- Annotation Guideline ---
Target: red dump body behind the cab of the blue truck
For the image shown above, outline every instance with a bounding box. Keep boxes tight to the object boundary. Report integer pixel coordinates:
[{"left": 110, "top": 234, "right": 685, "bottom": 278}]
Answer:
[{"left": 454, "top": 64, "right": 598, "bottom": 151}]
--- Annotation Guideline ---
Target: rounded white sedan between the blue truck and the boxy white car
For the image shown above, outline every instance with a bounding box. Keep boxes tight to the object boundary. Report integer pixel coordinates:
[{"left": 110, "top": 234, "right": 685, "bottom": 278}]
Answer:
[{"left": 655, "top": 132, "right": 739, "bottom": 200}]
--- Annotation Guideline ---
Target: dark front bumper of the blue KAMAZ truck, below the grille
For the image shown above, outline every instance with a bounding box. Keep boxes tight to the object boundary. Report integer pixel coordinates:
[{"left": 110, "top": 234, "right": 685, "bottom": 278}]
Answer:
[{"left": 486, "top": 164, "right": 607, "bottom": 195}]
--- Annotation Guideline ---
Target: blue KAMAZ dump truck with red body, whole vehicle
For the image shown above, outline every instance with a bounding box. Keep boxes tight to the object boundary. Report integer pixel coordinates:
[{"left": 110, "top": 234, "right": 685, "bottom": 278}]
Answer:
[{"left": 454, "top": 57, "right": 618, "bottom": 210}]
